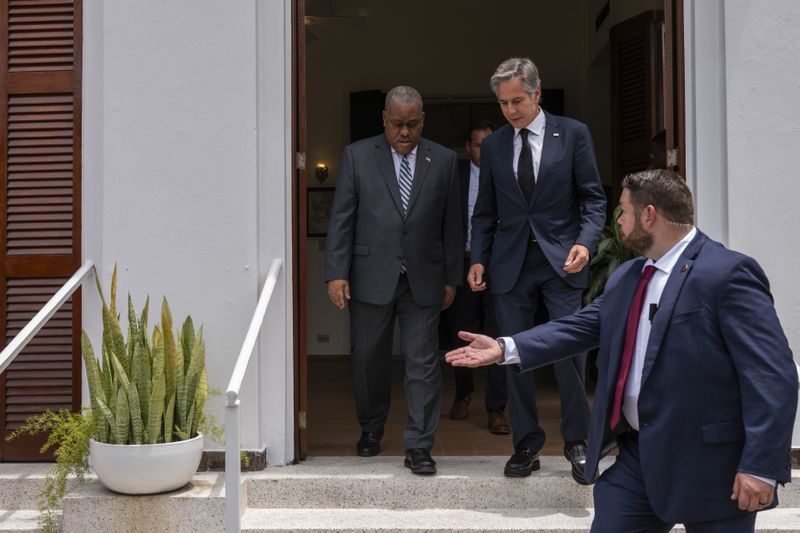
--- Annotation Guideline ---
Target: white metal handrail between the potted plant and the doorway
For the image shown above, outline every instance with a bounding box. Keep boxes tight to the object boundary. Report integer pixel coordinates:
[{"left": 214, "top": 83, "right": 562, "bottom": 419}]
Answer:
[{"left": 225, "top": 259, "right": 283, "bottom": 533}]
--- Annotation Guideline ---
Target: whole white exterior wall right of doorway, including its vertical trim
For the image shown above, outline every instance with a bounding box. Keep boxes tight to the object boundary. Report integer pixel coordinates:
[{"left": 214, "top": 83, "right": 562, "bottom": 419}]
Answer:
[{"left": 685, "top": 0, "right": 800, "bottom": 447}]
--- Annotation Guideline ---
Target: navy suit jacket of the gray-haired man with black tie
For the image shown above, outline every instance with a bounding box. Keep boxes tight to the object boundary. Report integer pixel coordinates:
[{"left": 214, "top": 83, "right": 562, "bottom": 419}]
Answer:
[{"left": 472, "top": 111, "right": 606, "bottom": 294}]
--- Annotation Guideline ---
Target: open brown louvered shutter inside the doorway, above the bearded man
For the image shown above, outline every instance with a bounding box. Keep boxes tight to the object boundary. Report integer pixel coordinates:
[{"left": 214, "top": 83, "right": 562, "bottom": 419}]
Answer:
[{"left": 609, "top": 11, "right": 664, "bottom": 204}]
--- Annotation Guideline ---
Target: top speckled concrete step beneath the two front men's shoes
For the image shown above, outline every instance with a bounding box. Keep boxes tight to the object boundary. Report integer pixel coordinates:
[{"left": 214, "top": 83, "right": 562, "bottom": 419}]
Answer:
[{"left": 247, "top": 456, "right": 596, "bottom": 510}]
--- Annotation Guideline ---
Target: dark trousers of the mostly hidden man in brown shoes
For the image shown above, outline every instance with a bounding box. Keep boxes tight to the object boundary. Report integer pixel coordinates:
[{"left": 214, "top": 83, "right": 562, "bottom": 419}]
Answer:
[{"left": 442, "top": 257, "right": 506, "bottom": 412}]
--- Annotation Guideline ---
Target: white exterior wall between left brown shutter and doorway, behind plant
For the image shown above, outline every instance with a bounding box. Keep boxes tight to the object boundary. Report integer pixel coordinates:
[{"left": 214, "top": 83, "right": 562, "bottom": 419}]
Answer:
[{"left": 83, "top": 0, "right": 293, "bottom": 464}]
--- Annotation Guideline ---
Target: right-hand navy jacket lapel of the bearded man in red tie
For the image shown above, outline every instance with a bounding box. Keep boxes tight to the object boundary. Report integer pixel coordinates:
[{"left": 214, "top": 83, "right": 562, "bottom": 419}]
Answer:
[{"left": 641, "top": 231, "right": 707, "bottom": 386}]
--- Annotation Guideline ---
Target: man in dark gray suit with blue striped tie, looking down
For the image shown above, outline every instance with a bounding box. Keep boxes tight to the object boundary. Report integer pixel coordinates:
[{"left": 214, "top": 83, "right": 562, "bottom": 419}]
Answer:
[{"left": 325, "top": 86, "right": 464, "bottom": 474}]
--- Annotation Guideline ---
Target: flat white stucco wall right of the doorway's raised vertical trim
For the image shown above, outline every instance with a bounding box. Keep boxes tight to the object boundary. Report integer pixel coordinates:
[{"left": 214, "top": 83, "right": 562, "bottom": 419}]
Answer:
[{"left": 725, "top": 0, "right": 800, "bottom": 354}]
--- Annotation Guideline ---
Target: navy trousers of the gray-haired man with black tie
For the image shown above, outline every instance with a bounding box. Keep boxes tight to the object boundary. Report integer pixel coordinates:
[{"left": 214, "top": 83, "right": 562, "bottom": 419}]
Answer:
[{"left": 492, "top": 243, "right": 589, "bottom": 452}]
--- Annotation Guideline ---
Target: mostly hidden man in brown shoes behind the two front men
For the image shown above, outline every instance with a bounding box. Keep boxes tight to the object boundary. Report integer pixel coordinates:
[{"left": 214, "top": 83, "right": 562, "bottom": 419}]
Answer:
[{"left": 442, "top": 121, "right": 511, "bottom": 435}]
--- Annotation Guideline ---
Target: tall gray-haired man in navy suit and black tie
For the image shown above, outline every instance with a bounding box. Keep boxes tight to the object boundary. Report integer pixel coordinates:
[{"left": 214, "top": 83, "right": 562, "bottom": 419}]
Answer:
[{"left": 467, "top": 58, "right": 606, "bottom": 477}]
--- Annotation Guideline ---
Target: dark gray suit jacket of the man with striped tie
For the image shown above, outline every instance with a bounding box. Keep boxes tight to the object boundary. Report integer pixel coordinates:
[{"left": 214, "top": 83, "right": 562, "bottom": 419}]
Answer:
[{"left": 325, "top": 135, "right": 464, "bottom": 306}]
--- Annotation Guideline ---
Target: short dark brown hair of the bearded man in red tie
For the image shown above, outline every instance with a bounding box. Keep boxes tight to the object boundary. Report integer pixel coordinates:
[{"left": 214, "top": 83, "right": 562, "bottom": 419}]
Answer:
[{"left": 622, "top": 168, "right": 694, "bottom": 224}]
